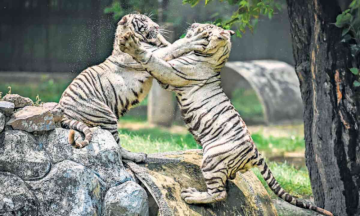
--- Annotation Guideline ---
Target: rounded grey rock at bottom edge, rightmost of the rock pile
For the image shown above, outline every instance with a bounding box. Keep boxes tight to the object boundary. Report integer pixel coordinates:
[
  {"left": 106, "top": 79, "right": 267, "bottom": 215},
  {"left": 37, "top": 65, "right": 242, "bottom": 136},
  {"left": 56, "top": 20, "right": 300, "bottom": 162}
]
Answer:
[{"left": 104, "top": 181, "right": 149, "bottom": 216}]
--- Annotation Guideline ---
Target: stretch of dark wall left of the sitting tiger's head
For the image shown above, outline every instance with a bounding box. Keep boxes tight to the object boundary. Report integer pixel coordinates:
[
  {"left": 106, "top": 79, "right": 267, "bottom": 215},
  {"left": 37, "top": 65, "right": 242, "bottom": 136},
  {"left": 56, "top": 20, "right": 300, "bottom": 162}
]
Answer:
[{"left": 0, "top": 0, "right": 115, "bottom": 72}]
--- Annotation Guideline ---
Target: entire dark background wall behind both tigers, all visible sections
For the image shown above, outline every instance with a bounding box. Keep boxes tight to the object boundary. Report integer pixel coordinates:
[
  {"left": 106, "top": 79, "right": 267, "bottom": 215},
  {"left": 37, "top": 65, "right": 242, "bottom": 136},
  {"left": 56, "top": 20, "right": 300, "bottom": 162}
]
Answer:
[{"left": 0, "top": 0, "right": 293, "bottom": 72}]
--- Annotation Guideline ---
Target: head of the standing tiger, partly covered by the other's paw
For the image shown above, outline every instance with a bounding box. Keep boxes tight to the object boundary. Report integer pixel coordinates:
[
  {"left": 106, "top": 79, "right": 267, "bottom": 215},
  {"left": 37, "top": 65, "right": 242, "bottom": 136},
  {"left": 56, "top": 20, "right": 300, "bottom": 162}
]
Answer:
[{"left": 186, "top": 23, "right": 234, "bottom": 53}]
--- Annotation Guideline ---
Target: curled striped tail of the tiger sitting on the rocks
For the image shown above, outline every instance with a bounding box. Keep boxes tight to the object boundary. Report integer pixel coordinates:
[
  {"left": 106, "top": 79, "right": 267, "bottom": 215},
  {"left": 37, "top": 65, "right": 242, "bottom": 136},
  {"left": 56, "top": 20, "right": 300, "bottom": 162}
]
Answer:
[{"left": 61, "top": 120, "right": 92, "bottom": 148}]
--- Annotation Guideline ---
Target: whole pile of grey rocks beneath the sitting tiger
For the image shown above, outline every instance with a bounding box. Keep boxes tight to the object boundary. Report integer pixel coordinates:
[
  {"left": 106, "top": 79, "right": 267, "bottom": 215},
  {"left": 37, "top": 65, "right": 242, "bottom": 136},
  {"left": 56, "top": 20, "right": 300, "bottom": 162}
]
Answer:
[{"left": 0, "top": 95, "right": 149, "bottom": 216}]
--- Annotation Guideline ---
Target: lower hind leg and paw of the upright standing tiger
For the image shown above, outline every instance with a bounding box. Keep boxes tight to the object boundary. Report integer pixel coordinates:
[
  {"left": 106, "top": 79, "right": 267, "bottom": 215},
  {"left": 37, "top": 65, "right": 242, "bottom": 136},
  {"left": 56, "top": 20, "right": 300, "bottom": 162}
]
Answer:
[{"left": 181, "top": 159, "right": 227, "bottom": 204}]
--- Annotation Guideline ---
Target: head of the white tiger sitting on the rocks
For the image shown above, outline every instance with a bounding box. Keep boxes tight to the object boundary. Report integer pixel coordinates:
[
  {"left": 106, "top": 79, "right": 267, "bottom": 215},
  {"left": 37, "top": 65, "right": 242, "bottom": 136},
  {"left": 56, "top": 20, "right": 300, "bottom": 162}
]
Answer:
[{"left": 114, "top": 14, "right": 170, "bottom": 52}]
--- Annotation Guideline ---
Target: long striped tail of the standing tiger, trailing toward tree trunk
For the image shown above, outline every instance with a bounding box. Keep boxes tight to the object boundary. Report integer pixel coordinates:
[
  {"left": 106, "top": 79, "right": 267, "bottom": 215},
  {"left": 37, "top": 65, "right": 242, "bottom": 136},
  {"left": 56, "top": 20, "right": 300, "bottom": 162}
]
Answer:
[{"left": 257, "top": 158, "right": 333, "bottom": 216}]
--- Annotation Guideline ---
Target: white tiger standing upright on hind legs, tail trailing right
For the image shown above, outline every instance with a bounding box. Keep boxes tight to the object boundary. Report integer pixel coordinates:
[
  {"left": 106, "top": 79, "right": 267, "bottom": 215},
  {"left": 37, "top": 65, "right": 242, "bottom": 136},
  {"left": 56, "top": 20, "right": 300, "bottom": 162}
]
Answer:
[{"left": 120, "top": 23, "right": 332, "bottom": 216}]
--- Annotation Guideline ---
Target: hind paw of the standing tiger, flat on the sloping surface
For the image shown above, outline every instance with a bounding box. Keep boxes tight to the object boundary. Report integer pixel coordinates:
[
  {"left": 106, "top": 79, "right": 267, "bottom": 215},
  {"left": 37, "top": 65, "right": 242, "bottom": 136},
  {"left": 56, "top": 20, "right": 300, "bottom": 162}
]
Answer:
[{"left": 181, "top": 188, "right": 226, "bottom": 204}]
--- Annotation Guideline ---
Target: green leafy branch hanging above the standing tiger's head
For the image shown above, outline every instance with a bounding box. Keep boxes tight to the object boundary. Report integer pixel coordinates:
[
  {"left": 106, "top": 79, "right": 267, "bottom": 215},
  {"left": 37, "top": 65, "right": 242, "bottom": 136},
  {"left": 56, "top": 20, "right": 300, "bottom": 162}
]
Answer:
[{"left": 183, "top": 0, "right": 282, "bottom": 37}]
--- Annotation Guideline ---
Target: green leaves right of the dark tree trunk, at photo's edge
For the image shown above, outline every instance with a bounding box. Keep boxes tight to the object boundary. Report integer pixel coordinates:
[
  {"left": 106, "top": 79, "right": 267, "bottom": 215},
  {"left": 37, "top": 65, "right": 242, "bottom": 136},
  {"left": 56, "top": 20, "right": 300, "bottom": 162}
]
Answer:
[{"left": 335, "top": 0, "right": 360, "bottom": 87}]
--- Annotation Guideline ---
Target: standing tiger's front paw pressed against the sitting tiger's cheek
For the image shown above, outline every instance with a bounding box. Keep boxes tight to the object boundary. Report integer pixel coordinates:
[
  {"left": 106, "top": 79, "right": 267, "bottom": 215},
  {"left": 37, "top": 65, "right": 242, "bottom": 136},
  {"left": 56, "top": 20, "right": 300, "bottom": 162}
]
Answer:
[{"left": 119, "top": 32, "right": 142, "bottom": 58}]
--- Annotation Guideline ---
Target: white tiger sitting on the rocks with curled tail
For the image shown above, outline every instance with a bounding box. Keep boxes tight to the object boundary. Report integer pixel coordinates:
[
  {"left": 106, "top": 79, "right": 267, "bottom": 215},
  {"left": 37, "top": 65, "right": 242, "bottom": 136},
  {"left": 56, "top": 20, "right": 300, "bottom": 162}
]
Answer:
[{"left": 59, "top": 14, "right": 208, "bottom": 162}]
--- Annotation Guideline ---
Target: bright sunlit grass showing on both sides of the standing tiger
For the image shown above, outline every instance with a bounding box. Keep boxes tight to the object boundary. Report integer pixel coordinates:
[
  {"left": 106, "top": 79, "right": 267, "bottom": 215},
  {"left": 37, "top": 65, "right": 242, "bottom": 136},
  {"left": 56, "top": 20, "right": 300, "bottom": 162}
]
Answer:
[{"left": 119, "top": 125, "right": 312, "bottom": 198}]
